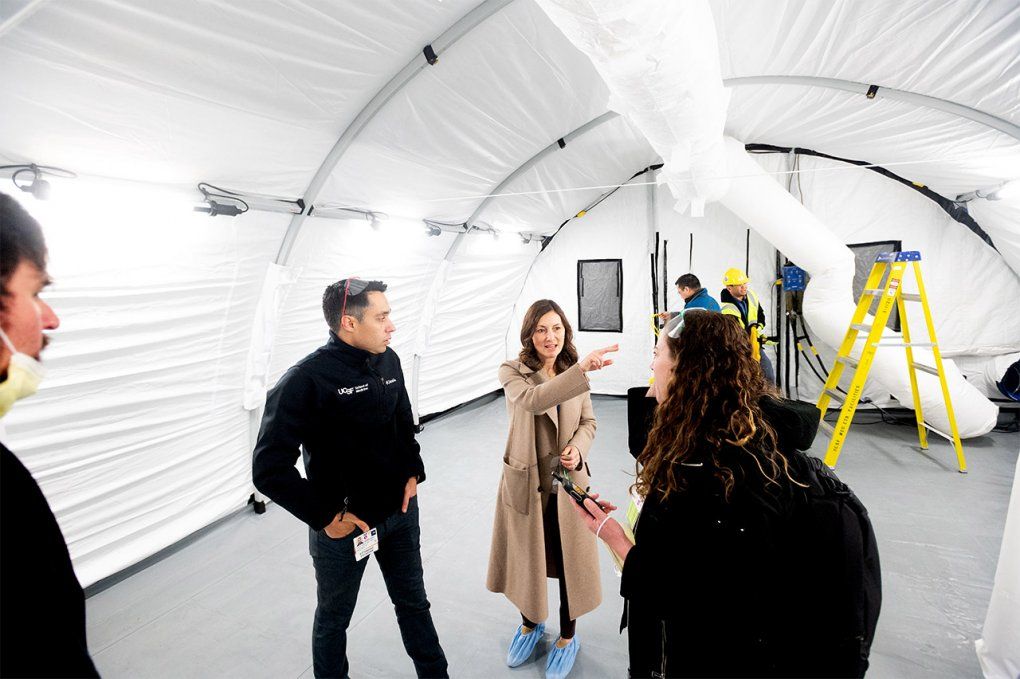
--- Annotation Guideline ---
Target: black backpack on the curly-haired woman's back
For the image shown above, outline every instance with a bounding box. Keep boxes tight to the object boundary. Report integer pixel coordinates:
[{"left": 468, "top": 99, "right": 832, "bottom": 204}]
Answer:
[{"left": 795, "top": 456, "right": 882, "bottom": 677}]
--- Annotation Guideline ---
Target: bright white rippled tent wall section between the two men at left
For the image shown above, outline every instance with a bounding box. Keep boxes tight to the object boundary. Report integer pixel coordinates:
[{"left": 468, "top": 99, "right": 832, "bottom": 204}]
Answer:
[{"left": 2, "top": 187, "right": 285, "bottom": 585}]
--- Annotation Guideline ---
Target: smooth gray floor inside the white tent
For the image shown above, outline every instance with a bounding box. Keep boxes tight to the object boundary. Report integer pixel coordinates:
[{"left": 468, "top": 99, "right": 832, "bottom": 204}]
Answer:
[{"left": 88, "top": 398, "right": 1020, "bottom": 679}]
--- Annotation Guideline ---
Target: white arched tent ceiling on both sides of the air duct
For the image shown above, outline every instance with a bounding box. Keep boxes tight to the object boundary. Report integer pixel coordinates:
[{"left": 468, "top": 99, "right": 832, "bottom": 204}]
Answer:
[{"left": 0, "top": 0, "right": 1020, "bottom": 256}]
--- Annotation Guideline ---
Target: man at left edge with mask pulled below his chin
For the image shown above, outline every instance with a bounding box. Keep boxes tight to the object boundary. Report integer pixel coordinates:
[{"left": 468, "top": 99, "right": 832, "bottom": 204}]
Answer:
[{"left": 0, "top": 194, "right": 99, "bottom": 677}]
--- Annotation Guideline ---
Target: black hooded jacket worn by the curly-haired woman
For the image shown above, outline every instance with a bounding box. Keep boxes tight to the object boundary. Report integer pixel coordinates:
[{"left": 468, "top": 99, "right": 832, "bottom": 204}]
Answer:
[{"left": 620, "top": 399, "right": 869, "bottom": 677}]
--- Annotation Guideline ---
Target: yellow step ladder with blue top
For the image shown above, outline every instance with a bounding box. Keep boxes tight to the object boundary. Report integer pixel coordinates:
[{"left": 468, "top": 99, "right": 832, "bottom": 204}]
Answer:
[{"left": 817, "top": 250, "right": 967, "bottom": 474}]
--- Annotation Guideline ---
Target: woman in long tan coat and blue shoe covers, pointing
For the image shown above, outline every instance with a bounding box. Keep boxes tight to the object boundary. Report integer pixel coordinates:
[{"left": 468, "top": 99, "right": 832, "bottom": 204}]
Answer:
[{"left": 487, "top": 300, "right": 617, "bottom": 678}]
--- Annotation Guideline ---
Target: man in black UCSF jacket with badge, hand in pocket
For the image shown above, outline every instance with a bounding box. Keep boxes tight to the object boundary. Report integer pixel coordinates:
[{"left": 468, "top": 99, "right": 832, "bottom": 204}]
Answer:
[{"left": 253, "top": 278, "right": 447, "bottom": 677}]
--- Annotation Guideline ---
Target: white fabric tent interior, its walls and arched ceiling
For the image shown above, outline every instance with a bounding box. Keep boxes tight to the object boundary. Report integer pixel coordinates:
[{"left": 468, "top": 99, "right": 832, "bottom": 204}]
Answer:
[{"left": 0, "top": 0, "right": 1020, "bottom": 664}]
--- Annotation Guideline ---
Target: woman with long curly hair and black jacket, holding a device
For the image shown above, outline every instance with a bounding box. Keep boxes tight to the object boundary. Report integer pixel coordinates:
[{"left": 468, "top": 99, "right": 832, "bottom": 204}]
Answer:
[{"left": 577, "top": 311, "right": 877, "bottom": 677}]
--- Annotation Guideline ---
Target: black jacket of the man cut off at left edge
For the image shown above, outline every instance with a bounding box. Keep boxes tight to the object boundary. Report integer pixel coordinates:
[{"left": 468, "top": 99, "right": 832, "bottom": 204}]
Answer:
[{"left": 0, "top": 443, "right": 99, "bottom": 677}]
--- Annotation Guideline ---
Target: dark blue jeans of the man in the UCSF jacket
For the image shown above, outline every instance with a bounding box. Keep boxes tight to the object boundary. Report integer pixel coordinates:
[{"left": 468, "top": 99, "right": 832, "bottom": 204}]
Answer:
[{"left": 308, "top": 491, "right": 448, "bottom": 678}]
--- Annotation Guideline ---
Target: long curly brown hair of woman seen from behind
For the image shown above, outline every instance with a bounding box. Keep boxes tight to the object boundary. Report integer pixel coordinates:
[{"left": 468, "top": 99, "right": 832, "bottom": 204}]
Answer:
[{"left": 634, "top": 311, "right": 802, "bottom": 501}]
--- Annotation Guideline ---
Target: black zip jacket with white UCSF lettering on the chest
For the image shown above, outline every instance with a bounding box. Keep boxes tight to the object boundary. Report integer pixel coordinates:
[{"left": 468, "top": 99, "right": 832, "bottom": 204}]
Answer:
[{"left": 252, "top": 332, "right": 425, "bottom": 530}]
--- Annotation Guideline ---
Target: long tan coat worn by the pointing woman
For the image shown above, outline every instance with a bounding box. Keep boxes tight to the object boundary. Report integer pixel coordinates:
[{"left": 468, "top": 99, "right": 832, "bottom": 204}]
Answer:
[{"left": 486, "top": 361, "right": 602, "bottom": 622}]
